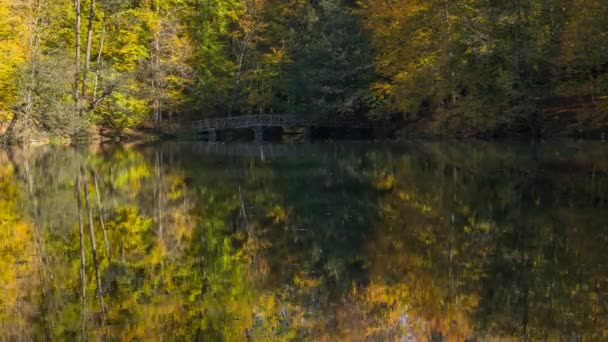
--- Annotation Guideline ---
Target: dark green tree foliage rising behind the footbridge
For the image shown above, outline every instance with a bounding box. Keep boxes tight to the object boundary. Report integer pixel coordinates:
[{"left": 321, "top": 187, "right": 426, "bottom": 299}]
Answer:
[{"left": 279, "top": 0, "right": 371, "bottom": 116}]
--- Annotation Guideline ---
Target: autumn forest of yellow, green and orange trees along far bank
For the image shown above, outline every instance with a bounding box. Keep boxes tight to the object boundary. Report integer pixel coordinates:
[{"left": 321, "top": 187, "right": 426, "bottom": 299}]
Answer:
[{"left": 0, "top": 0, "right": 608, "bottom": 142}]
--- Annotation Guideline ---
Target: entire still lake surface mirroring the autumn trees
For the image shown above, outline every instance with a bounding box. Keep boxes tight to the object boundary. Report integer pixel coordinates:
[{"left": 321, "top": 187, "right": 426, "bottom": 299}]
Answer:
[{"left": 0, "top": 142, "right": 608, "bottom": 341}]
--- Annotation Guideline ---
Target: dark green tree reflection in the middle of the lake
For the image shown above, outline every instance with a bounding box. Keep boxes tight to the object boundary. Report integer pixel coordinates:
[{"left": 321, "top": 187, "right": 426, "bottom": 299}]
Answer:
[{"left": 251, "top": 147, "right": 376, "bottom": 339}]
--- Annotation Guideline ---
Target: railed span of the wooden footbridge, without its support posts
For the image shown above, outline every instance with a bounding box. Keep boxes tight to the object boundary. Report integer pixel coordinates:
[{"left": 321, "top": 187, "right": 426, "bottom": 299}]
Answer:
[{"left": 192, "top": 115, "right": 367, "bottom": 132}]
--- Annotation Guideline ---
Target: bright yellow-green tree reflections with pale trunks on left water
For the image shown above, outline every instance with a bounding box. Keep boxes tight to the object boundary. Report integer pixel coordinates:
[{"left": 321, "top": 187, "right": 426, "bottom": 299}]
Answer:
[{"left": 0, "top": 144, "right": 306, "bottom": 340}]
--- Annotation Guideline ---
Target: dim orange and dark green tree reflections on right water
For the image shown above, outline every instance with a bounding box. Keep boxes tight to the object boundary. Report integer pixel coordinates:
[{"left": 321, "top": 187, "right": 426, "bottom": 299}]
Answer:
[{"left": 354, "top": 145, "right": 608, "bottom": 340}]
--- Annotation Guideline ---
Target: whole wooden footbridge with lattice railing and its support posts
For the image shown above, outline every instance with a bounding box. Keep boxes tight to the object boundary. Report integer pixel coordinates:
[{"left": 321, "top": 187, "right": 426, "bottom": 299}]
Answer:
[{"left": 192, "top": 114, "right": 369, "bottom": 142}]
